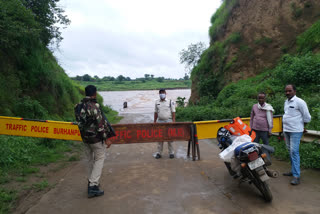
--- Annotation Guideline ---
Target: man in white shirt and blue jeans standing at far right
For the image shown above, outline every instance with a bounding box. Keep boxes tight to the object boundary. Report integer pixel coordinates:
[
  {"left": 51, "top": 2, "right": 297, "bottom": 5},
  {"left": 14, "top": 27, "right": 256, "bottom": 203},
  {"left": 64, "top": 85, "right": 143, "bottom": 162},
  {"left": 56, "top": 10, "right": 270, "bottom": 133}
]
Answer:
[{"left": 282, "top": 84, "right": 311, "bottom": 185}]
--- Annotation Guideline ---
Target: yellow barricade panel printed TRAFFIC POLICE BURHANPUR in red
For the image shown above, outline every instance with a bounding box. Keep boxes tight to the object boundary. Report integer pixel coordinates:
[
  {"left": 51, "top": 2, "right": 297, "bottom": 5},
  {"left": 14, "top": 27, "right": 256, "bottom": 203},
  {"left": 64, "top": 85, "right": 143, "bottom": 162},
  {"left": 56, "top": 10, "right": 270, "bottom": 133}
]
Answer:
[{"left": 0, "top": 116, "right": 82, "bottom": 141}]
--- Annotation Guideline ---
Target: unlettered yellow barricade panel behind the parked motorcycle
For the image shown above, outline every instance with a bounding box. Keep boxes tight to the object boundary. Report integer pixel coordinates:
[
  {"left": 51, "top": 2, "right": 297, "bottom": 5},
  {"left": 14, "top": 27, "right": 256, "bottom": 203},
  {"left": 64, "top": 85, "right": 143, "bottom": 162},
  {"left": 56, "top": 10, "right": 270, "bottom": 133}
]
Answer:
[{"left": 194, "top": 116, "right": 282, "bottom": 139}]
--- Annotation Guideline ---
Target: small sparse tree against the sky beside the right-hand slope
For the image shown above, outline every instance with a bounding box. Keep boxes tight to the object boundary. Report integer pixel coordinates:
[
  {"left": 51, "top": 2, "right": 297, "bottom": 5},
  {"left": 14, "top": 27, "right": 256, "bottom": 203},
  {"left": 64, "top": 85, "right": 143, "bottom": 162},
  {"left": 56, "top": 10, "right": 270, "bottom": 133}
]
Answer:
[{"left": 179, "top": 42, "right": 206, "bottom": 73}]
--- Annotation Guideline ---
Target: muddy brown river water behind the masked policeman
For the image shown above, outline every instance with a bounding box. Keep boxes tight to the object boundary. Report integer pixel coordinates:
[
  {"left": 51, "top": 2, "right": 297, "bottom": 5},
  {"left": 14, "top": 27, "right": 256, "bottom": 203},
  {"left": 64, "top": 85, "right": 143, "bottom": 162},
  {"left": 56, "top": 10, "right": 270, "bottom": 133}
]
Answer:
[{"left": 99, "top": 89, "right": 191, "bottom": 115}]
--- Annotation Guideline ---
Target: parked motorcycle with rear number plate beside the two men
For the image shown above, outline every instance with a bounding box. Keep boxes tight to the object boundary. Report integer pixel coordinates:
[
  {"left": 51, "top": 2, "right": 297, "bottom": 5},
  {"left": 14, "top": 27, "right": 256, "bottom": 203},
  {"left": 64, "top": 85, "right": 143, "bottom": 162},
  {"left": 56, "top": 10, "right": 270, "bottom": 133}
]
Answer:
[{"left": 217, "top": 127, "right": 278, "bottom": 202}]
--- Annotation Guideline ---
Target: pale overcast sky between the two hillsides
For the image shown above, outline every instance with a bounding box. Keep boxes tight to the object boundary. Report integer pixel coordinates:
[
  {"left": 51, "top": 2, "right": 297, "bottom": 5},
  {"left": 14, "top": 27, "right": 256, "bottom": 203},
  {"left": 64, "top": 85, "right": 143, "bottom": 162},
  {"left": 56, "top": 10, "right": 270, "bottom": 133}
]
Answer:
[{"left": 55, "top": 0, "right": 221, "bottom": 78}]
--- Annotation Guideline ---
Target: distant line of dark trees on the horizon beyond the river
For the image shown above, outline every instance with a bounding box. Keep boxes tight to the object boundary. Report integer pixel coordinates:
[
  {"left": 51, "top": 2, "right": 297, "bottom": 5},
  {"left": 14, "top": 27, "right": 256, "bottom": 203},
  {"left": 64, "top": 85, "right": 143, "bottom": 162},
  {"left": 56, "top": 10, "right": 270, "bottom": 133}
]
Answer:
[{"left": 71, "top": 74, "right": 189, "bottom": 82}]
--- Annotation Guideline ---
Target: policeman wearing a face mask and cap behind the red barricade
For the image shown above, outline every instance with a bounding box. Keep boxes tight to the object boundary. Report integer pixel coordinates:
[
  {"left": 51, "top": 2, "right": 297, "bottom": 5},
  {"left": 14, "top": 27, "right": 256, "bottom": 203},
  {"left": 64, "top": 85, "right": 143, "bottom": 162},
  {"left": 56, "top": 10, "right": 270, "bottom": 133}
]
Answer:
[{"left": 154, "top": 89, "right": 176, "bottom": 159}]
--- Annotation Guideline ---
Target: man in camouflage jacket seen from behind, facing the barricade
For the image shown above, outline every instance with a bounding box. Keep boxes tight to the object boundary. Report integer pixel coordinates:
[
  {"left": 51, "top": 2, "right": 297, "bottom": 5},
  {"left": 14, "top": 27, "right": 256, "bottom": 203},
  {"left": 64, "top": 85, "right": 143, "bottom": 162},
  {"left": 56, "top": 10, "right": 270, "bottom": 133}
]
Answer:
[{"left": 79, "top": 85, "right": 111, "bottom": 198}]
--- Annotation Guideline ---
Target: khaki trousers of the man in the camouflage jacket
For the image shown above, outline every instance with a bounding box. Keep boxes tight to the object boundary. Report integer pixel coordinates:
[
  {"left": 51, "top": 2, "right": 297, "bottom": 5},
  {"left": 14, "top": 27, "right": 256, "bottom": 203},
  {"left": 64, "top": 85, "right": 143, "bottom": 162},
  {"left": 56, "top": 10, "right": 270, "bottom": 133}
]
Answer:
[{"left": 84, "top": 142, "right": 106, "bottom": 186}]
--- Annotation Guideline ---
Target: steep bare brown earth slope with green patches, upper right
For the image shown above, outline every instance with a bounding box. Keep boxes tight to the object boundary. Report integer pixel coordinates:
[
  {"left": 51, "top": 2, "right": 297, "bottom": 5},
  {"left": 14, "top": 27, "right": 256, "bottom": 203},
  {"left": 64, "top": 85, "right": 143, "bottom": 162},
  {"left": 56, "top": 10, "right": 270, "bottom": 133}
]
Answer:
[{"left": 191, "top": 0, "right": 320, "bottom": 102}]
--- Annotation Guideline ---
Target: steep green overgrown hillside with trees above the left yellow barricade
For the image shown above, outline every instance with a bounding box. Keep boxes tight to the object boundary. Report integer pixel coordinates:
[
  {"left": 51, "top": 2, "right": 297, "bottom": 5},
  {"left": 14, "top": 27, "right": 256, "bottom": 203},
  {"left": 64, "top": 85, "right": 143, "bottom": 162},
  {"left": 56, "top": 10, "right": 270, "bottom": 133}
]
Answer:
[{"left": 0, "top": 0, "right": 81, "bottom": 120}]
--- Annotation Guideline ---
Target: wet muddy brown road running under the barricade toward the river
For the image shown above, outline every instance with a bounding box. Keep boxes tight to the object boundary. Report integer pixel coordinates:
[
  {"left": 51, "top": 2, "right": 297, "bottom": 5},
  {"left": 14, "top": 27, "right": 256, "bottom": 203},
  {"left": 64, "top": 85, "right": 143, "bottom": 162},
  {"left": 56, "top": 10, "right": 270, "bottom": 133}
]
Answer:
[{"left": 22, "top": 114, "right": 320, "bottom": 214}]
